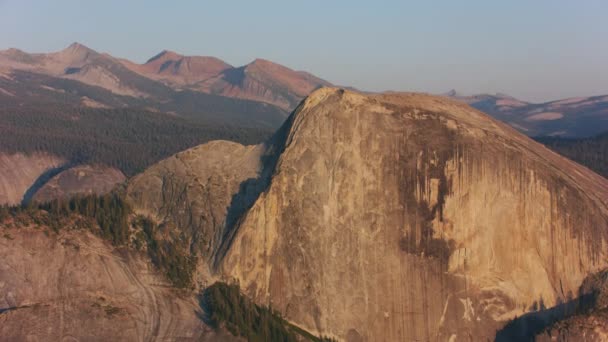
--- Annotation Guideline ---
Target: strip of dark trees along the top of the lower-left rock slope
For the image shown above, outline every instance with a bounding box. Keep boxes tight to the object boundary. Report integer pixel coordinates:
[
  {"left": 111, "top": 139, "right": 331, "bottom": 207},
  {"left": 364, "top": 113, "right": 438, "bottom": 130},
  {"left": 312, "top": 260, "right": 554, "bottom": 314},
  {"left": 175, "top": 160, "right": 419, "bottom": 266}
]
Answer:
[{"left": 0, "top": 192, "right": 197, "bottom": 288}]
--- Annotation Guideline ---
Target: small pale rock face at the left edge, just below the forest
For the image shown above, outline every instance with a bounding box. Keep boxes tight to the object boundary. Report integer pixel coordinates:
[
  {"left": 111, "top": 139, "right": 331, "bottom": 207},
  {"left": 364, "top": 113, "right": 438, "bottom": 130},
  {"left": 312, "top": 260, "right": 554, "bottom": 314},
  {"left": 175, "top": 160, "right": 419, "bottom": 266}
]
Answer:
[{"left": 0, "top": 153, "right": 66, "bottom": 205}]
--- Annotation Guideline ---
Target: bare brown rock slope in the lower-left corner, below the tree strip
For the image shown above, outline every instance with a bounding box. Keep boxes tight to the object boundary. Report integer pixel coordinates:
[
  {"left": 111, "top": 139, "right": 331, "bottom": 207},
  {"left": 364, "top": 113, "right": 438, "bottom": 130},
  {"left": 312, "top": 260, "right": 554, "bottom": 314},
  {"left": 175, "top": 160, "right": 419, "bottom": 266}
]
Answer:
[{"left": 0, "top": 228, "right": 230, "bottom": 341}]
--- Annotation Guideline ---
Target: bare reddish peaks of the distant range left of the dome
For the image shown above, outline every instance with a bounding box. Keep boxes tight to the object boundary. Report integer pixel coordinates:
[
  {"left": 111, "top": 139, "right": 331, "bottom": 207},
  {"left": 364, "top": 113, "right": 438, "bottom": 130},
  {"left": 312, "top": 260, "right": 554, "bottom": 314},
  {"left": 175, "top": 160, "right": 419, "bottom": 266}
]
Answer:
[{"left": 0, "top": 43, "right": 331, "bottom": 117}]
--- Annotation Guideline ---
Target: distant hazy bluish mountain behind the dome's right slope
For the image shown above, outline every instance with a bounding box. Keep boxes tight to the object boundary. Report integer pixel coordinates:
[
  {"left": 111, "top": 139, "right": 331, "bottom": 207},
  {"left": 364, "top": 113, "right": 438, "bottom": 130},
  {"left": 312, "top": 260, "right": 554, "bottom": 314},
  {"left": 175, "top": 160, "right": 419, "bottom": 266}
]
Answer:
[{"left": 444, "top": 90, "right": 608, "bottom": 138}]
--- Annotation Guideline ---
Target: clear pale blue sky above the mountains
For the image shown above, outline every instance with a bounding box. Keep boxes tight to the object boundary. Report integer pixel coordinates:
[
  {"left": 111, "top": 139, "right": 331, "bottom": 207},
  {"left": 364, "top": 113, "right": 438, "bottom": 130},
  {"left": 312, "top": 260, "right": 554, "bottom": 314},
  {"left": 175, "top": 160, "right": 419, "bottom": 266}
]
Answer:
[{"left": 0, "top": 0, "right": 608, "bottom": 101}]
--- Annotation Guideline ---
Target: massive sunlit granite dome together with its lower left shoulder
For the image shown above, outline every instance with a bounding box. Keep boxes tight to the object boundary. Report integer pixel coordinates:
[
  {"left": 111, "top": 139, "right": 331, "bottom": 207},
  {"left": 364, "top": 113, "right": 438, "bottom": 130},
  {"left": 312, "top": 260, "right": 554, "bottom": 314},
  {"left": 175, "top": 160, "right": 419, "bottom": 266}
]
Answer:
[{"left": 126, "top": 88, "right": 608, "bottom": 341}]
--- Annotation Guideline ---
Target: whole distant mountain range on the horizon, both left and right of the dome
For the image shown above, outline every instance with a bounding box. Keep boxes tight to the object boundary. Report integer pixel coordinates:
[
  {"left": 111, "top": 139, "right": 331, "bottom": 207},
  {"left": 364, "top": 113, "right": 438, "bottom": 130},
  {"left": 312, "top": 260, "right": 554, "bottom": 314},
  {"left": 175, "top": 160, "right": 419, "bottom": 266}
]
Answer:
[{"left": 0, "top": 43, "right": 608, "bottom": 138}]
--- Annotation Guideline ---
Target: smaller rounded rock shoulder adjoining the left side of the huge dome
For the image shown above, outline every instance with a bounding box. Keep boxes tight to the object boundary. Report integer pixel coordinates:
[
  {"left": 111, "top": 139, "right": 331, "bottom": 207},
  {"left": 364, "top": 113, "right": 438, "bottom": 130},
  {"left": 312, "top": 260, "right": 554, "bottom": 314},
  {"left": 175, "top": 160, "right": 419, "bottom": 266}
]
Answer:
[{"left": 126, "top": 141, "right": 265, "bottom": 260}]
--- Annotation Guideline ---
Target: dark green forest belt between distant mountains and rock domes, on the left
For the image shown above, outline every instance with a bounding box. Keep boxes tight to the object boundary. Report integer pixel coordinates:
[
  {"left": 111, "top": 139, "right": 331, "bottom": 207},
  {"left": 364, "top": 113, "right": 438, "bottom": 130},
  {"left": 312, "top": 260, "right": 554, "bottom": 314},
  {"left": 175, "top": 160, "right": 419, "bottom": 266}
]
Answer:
[{"left": 0, "top": 104, "right": 272, "bottom": 176}]
